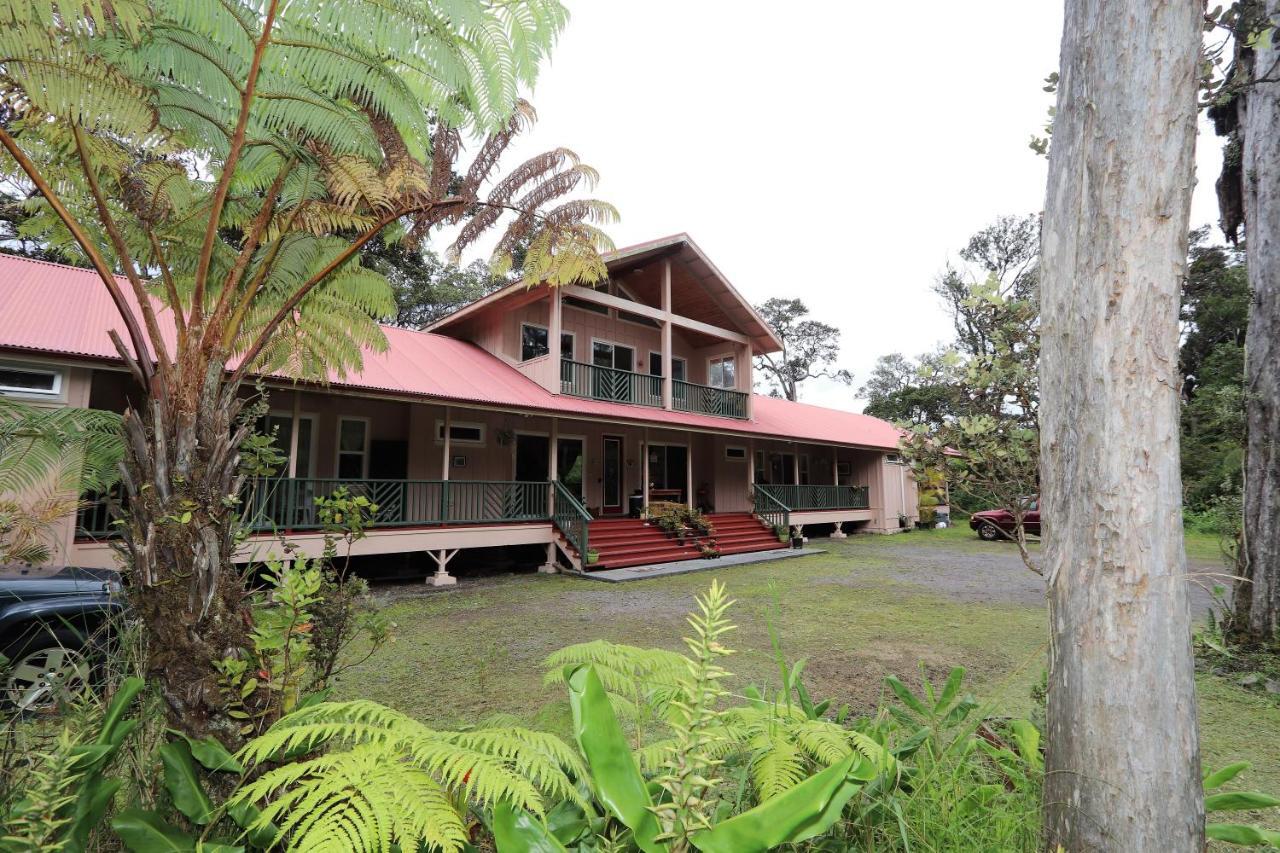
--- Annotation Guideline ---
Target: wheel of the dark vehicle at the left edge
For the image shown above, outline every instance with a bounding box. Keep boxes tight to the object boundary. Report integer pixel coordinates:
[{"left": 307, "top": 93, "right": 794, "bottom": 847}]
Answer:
[{"left": 0, "top": 630, "right": 93, "bottom": 713}]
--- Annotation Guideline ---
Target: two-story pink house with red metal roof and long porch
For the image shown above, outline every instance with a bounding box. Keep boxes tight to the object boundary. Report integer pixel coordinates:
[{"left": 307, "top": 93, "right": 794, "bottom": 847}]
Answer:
[{"left": 0, "top": 234, "right": 918, "bottom": 583}]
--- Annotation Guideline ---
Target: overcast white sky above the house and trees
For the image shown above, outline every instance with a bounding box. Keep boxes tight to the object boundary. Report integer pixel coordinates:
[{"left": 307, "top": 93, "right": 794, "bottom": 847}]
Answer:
[{"left": 458, "top": 0, "right": 1220, "bottom": 411}]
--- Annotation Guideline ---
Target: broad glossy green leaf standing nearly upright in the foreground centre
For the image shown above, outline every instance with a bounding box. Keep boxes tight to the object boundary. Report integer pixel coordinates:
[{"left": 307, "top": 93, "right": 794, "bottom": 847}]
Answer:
[{"left": 564, "top": 663, "right": 667, "bottom": 853}]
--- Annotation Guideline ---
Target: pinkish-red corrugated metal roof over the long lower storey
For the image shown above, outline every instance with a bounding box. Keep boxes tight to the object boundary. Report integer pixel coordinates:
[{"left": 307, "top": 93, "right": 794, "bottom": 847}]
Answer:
[{"left": 0, "top": 255, "right": 899, "bottom": 450}]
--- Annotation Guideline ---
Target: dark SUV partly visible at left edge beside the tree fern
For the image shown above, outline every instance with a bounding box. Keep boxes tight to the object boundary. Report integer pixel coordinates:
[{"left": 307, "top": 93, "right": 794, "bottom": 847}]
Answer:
[{"left": 0, "top": 566, "right": 124, "bottom": 711}]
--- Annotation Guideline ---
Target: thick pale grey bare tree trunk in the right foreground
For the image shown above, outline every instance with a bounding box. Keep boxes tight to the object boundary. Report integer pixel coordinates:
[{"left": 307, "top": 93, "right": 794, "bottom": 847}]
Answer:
[{"left": 1041, "top": 0, "right": 1204, "bottom": 852}]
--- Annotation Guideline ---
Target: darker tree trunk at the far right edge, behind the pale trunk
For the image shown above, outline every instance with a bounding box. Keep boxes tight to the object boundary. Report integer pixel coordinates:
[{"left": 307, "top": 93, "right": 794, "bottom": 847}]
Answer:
[{"left": 1234, "top": 0, "right": 1280, "bottom": 646}]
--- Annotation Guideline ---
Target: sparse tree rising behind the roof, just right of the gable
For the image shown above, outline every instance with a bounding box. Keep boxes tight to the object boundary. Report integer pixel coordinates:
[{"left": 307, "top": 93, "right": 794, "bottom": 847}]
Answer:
[{"left": 755, "top": 297, "right": 854, "bottom": 401}]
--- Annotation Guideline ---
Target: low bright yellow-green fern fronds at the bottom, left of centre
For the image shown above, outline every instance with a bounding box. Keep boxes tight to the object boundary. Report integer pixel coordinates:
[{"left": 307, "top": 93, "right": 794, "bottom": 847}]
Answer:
[{"left": 232, "top": 701, "right": 584, "bottom": 850}]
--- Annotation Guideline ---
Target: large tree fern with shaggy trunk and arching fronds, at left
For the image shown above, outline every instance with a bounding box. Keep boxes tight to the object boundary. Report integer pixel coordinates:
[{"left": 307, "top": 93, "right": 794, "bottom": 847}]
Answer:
[{"left": 0, "top": 0, "right": 613, "bottom": 742}]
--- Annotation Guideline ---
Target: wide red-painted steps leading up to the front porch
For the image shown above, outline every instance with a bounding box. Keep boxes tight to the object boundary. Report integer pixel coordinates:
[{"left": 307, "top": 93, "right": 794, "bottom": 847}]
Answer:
[{"left": 588, "top": 512, "right": 785, "bottom": 570}]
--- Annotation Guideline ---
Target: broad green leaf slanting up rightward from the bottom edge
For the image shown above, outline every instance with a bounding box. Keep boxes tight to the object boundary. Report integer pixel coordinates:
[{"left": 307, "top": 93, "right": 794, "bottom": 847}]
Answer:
[{"left": 690, "top": 753, "right": 876, "bottom": 853}]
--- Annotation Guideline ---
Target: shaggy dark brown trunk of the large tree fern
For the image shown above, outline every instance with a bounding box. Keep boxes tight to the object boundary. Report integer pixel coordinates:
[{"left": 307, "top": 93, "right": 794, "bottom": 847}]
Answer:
[{"left": 123, "top": 347, "right": 256, "bottom": 745}]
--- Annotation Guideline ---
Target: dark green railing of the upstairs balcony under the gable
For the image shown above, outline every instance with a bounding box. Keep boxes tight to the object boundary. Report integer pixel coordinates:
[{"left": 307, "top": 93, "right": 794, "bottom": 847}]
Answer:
[{"left": 561, "top": 359, "right": 748, "bottom": 420}]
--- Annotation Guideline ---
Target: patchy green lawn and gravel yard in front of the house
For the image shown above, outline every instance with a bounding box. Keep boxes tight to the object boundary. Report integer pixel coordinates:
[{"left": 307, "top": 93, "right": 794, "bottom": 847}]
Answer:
[{"left": 338, "top": 528, "right": 1280, "bottom": 793}]
